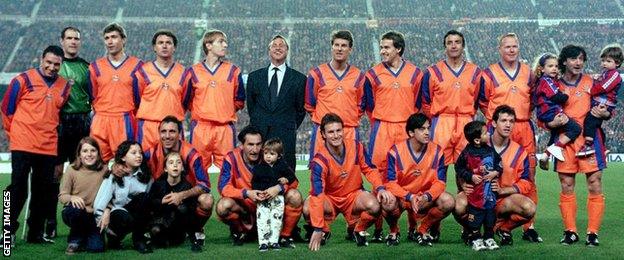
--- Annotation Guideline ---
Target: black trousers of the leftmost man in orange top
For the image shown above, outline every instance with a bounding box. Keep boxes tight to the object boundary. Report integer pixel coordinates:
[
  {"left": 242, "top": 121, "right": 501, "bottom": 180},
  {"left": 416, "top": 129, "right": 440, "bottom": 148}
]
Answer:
[{"left": 7, "top": 151, "right": 57, "bottom": 240}]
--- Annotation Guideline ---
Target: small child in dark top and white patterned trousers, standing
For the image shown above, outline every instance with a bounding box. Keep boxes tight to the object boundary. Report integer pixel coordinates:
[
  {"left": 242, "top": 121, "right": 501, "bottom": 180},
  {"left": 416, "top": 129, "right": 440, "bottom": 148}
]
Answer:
[{"left": 251, "top": 138, "right": 296, "bottom": 252}]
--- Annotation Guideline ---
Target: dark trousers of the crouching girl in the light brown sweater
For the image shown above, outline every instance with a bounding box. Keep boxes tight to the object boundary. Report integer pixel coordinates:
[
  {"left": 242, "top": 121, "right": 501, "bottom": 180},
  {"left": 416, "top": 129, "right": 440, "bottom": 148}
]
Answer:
[{"left": 62, "top": 206, "right": 104, "bottom": 252}]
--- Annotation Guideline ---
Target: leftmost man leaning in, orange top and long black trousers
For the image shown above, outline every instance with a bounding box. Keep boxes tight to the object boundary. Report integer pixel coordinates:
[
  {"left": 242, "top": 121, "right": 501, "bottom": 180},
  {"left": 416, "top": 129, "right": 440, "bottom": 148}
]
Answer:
[{"left": 2, "top": 46, "right": 71, "bottom": 244}]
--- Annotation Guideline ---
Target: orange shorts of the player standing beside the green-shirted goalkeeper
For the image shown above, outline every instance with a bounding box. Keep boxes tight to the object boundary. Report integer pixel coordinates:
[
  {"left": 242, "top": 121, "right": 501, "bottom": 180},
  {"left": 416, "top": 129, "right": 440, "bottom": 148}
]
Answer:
[{"left": 91, "top": 112, "right": 137, "bottom": 162}]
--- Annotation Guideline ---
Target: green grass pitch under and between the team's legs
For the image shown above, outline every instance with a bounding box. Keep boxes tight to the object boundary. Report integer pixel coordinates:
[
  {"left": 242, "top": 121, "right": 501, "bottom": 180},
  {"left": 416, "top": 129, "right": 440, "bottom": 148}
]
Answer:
[{"left": 0, "top": 164, "right": 624, "bottom": 259}]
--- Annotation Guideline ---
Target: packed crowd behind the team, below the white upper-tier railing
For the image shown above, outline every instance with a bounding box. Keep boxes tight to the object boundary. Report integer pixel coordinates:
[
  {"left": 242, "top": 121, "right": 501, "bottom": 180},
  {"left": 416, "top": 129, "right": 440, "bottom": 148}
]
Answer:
[{"left": 0, "top": 20, "right": 624, "bottom": 154}]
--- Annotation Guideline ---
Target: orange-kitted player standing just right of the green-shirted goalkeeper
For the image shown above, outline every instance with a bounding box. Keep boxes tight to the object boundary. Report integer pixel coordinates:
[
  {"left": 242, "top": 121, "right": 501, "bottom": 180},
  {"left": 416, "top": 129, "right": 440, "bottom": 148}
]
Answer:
[{"left": 89, "top": 23, "right": 143, "bottom": 162}]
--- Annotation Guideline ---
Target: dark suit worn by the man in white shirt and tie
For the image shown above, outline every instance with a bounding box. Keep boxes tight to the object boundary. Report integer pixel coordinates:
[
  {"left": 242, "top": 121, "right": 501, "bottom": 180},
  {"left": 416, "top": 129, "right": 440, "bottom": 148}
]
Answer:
[{"left": 246, "top": 67, "right": 306, "bottom": 170}]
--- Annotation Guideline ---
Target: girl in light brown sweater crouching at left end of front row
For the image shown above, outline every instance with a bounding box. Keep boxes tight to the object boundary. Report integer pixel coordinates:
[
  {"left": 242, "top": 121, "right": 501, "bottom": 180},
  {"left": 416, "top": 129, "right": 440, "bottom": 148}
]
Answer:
[{"left": 59, "top": 137, "right": 108, "bottom": 255}]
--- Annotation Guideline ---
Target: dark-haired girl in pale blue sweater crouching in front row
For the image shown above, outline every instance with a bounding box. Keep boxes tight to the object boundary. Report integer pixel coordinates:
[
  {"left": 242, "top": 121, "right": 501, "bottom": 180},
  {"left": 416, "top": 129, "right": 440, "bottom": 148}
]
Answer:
[{"left": 94, "top": 141, "right": 152, "bottom": 254}]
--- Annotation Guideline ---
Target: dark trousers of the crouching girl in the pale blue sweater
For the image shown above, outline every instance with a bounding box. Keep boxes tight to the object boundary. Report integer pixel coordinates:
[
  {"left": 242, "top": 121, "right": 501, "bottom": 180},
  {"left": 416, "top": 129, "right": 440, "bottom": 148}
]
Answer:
[{"left": 108, "top": 193, "right": 149, "bottom": 244}]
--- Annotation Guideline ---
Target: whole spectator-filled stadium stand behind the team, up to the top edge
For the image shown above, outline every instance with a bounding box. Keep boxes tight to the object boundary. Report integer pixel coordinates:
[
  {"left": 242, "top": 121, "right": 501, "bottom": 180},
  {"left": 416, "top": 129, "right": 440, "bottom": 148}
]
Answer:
[{"left": 0, "top": 0, "right": 624, "bottom": 153}]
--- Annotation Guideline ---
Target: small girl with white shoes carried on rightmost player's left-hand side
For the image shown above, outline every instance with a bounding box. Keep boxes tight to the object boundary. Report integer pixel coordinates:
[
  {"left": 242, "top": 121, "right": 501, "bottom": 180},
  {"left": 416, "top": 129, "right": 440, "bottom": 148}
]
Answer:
[{"left": 535, "top": 53, "right": 581, "bottom": 170}]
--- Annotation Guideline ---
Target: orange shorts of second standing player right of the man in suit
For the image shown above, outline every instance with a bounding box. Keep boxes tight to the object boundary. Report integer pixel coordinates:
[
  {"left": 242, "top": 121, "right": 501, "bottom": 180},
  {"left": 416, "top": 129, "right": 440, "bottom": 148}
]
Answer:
[{"left": 368, "top": 120, "right": 408, "bottom": 172}]
